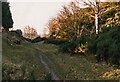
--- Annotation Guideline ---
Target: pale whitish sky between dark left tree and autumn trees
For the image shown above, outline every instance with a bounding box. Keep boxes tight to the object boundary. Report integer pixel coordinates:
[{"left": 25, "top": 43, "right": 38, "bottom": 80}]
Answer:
[{"left": 9, "top": 0, "right": 71, "bottom": 35}]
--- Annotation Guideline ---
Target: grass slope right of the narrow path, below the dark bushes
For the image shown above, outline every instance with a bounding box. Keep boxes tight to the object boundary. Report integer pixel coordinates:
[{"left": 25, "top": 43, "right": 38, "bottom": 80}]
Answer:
[{"left": 34, "top": 42, "right": 113, "bottom": 80}]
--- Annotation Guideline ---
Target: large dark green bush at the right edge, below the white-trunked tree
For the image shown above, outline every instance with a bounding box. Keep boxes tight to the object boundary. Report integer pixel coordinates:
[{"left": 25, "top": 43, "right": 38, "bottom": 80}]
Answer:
[{"left": 88, "top": 26, "right": 120, "bottom": 64}]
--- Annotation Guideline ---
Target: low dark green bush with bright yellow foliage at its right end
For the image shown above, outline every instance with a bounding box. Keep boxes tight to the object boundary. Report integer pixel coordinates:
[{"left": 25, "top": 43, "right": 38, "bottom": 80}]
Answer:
[{"left": 60, "top": 36, "right": 87, "bottom": 54}]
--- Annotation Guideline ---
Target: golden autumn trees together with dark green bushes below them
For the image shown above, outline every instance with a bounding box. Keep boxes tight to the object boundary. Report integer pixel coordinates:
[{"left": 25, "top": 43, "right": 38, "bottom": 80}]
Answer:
[{"left": 46, "top": 0, "right": 120, "bottom": 65}]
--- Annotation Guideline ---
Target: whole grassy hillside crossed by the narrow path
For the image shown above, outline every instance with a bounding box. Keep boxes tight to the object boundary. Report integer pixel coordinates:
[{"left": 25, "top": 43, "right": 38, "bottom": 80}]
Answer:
[{"left": 2, "top": 32, "right": 120, "bottom": 80}]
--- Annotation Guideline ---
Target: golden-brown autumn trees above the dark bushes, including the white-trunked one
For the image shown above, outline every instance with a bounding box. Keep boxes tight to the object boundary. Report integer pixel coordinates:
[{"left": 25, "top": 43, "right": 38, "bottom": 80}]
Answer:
[{"left": 48, "top": 0, "right": 120, "bottom": 40}]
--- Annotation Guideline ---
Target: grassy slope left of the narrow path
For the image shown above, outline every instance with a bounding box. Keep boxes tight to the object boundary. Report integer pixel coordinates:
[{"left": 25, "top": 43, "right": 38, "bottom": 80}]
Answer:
[{"left": 2, "top": 34, "right": 45, "bottom": 80}]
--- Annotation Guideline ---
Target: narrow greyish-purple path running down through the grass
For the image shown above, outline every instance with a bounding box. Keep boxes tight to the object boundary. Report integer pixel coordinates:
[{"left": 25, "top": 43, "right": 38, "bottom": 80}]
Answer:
[{"left": 40, "top": 53, "right": 59, "bottom": 80}]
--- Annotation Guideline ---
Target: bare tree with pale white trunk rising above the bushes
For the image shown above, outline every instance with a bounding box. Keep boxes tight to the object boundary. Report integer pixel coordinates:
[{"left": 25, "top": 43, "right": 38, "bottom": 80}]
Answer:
[{"left": 76, "top": 0, "right": 109, "bottom": 34}]
